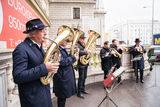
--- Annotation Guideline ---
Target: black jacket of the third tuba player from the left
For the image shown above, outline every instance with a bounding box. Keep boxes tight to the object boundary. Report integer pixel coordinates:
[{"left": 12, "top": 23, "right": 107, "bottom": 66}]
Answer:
[{"left": 76, "top": 42, "right": 89, "bottom": 68}]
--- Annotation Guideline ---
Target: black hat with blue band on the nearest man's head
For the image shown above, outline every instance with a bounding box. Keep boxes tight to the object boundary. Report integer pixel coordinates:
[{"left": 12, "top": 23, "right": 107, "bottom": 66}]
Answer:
[{"left": 23, "top": 19, "right": 47, "bottom": 34}]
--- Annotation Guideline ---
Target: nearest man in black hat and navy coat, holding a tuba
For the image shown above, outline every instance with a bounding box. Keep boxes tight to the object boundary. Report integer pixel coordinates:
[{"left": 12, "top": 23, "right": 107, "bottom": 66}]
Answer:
[{"left": 12, "top": 19, "right": 58, "bottom": 107}]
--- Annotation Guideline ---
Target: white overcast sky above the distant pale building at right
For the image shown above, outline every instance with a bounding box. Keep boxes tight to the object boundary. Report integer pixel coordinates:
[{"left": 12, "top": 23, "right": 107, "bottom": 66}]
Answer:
[{"left": 103, "top": 0, "right": 160, "bottom": 29}]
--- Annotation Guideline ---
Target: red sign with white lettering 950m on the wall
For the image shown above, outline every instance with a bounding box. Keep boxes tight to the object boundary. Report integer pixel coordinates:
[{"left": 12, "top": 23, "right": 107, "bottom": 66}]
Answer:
[{"left": 0, "top": 0, "right": 38, "bottom": 49}]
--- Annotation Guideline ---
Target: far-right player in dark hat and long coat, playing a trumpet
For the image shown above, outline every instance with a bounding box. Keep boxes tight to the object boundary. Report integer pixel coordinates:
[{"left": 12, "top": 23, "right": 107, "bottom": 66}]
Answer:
[{"left": 130, "top": 38, "right": 146, "bottom": 83}]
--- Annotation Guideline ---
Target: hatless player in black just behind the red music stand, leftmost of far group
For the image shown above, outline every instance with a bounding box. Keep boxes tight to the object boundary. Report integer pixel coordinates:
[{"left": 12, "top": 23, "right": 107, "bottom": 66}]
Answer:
[{"left": 100, "top": 41, "right": 113, "bottom": 79}]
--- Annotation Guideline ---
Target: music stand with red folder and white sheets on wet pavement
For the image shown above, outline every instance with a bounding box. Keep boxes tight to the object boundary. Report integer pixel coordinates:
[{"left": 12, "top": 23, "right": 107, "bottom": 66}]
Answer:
[{"left": 98, "top": 67, "right": 125, "bottom": 107}]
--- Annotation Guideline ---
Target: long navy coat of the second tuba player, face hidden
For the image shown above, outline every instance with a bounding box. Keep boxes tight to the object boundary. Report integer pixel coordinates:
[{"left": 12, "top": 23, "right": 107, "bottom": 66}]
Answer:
[{"left": 53, "top": 47, "right": 77, "bottom": 98}]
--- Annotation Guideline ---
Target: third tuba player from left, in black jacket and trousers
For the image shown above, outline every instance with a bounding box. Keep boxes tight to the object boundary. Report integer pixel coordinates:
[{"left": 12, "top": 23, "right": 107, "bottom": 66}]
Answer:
[{"left": 77, "top": 35, "right": 91, "bottom": 99}]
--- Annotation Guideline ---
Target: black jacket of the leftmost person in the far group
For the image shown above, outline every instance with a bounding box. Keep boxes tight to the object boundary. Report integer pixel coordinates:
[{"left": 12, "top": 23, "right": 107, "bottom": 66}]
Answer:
[{"left": 100, "top": 47, "right": 113, "bottom": 71}]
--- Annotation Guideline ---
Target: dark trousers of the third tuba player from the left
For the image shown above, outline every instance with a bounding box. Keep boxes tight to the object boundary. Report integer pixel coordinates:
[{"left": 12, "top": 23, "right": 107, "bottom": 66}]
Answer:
[{"left": 78, "top": 66, "right": 88, "bottom": 94}]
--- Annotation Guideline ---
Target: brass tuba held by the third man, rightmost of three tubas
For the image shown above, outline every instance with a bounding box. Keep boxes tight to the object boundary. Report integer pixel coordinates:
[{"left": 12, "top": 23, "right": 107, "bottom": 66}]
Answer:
[{"left": 80, "top": 30, "right": 101, "bottom": 65}]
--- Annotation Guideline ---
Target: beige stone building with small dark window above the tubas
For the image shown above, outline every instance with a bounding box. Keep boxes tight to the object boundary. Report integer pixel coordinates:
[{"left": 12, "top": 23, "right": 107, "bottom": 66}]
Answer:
[{"left": 49, "top": 0, "right": 105, "bottom": 45}]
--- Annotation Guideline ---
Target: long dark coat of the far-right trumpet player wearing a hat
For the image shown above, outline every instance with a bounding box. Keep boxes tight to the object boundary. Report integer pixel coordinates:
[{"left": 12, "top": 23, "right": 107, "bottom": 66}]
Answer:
[{"left": 130, "top": 45, "right": 146, "bottom": 69}]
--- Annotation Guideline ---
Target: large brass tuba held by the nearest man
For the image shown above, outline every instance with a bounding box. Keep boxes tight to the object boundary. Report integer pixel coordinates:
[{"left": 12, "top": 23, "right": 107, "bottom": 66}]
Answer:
[{"left": 40, "top": 25, "right": 74, "bottom": 85}]
